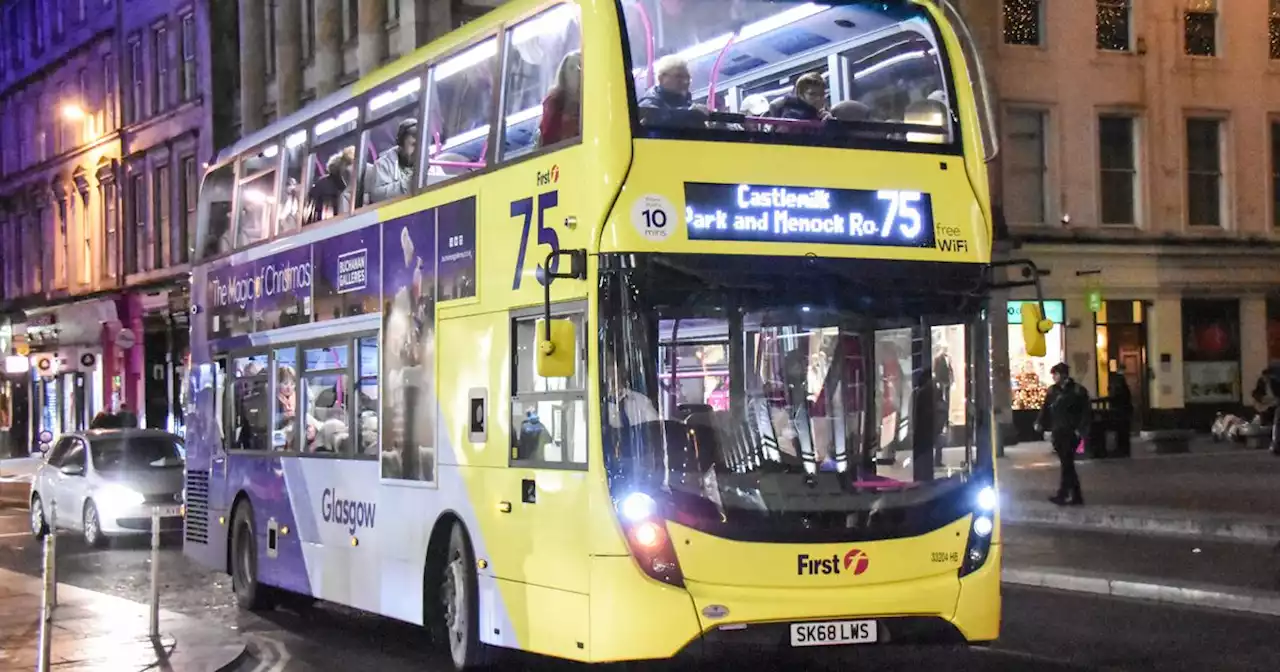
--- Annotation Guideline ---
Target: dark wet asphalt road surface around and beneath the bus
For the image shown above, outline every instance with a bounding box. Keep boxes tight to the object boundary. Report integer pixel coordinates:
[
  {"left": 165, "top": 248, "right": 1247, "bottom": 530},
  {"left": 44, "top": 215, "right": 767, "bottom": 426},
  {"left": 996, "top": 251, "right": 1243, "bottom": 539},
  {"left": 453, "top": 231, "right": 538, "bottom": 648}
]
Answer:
[{"left": 0, "top": 509, "right": 1280, "bottom": 672}]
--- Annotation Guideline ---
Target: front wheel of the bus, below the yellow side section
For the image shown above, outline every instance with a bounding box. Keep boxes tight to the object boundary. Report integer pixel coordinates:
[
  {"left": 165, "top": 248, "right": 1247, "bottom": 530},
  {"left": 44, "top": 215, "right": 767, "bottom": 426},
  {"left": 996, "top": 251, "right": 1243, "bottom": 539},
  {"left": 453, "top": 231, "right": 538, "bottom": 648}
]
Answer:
[{"left": 428, "top": 522, "right": 494, "bottom": 671}]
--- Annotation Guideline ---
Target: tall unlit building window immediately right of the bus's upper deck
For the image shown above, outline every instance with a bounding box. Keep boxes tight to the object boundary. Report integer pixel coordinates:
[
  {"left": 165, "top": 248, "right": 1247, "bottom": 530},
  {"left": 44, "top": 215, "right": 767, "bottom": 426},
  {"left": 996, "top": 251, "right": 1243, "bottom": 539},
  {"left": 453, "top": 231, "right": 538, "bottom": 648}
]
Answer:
[{"left": 1004, "top": 110, "right": 1048, "bottom": 224}]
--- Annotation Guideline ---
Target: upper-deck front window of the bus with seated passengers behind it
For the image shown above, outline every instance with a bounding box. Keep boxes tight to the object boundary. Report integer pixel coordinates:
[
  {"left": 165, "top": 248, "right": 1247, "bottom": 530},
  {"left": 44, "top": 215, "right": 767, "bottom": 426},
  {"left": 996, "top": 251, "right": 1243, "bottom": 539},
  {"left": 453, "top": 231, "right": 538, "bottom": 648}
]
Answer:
[{"left": 622, "top": 0, "right": 954, "bottom": 145}]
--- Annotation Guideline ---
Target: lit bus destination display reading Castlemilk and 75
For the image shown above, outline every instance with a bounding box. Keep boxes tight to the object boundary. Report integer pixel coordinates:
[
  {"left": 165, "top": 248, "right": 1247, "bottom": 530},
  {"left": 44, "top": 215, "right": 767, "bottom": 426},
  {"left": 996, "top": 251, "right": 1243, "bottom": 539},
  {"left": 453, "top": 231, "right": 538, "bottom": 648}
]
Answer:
[{"left": 685, "top": 182, "right": 934, "bottom": 247}]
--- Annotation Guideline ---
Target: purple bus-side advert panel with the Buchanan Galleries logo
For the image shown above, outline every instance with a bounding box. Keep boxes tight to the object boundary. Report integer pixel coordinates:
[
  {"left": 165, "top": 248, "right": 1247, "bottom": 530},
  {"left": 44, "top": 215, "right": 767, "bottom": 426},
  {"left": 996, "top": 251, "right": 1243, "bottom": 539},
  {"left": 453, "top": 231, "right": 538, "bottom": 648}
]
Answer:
[{"left": 314, "top": 224, "right": 383, "bottom": 321}]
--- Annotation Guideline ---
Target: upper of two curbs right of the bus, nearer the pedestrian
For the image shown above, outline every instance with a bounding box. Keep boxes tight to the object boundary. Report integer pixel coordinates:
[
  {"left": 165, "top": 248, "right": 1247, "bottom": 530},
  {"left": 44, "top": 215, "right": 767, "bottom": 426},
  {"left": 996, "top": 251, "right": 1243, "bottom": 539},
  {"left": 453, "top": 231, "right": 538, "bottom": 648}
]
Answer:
[{"left": 1002, "top": 502, "right": 1280, "bottom": 545}]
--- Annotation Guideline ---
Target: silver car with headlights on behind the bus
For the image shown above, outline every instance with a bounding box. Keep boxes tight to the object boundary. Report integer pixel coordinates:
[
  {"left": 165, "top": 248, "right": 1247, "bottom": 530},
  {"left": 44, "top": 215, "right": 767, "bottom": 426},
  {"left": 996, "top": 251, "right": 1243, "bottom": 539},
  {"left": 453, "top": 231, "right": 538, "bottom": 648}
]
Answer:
[{"left": 31, "top": 429, "right": 186, "bottom": 547}]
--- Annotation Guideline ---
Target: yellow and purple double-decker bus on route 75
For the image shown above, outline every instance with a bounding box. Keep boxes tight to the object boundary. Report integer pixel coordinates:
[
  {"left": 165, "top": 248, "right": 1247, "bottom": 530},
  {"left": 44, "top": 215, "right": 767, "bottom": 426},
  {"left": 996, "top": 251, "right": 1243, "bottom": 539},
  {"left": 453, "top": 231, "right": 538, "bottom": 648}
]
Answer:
[{"left": 184, "top": 0, "right": 1048, "bottom": 669}]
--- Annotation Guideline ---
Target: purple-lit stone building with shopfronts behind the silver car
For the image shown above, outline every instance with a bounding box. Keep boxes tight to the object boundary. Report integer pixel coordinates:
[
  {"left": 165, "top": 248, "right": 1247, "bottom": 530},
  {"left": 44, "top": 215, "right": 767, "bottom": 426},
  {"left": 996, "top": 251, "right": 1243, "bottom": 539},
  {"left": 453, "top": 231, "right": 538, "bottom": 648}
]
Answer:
[{"left": 0, "top": 0, "right": 214, "bottom": 456}]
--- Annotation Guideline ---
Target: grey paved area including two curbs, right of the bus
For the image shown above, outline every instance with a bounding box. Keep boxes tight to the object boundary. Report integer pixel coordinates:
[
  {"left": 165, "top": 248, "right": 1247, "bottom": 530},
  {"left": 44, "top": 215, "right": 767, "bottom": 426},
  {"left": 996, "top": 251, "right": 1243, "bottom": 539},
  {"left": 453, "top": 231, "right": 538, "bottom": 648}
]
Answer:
[{"left": 1000, "top": 436, "right": 1280, "bottom": 617}]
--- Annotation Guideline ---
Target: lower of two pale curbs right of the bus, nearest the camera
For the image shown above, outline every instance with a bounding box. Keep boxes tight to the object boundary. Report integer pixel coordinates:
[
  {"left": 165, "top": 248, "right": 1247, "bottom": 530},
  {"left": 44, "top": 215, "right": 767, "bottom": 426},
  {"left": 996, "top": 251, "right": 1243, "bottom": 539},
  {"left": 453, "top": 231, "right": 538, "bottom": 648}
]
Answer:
[{"left": 1001, "top": 567, "right": 1280, "bottom": 616}]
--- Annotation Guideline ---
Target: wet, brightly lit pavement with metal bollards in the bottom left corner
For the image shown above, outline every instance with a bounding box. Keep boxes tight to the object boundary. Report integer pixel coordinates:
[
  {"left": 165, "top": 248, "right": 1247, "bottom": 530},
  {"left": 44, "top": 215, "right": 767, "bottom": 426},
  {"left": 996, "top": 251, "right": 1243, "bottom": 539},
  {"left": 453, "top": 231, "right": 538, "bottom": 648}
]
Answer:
[{"left": 0, "top": 570, "right": 247, "bottom": 672}]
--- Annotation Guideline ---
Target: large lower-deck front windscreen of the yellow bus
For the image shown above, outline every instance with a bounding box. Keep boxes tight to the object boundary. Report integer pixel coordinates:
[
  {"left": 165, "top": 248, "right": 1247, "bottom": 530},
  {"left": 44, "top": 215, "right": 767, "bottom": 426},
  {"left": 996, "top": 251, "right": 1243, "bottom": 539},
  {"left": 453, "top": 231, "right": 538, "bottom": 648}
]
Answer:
[{"left": 600, "top": 255, "right": 989, "bottom": 541}]
